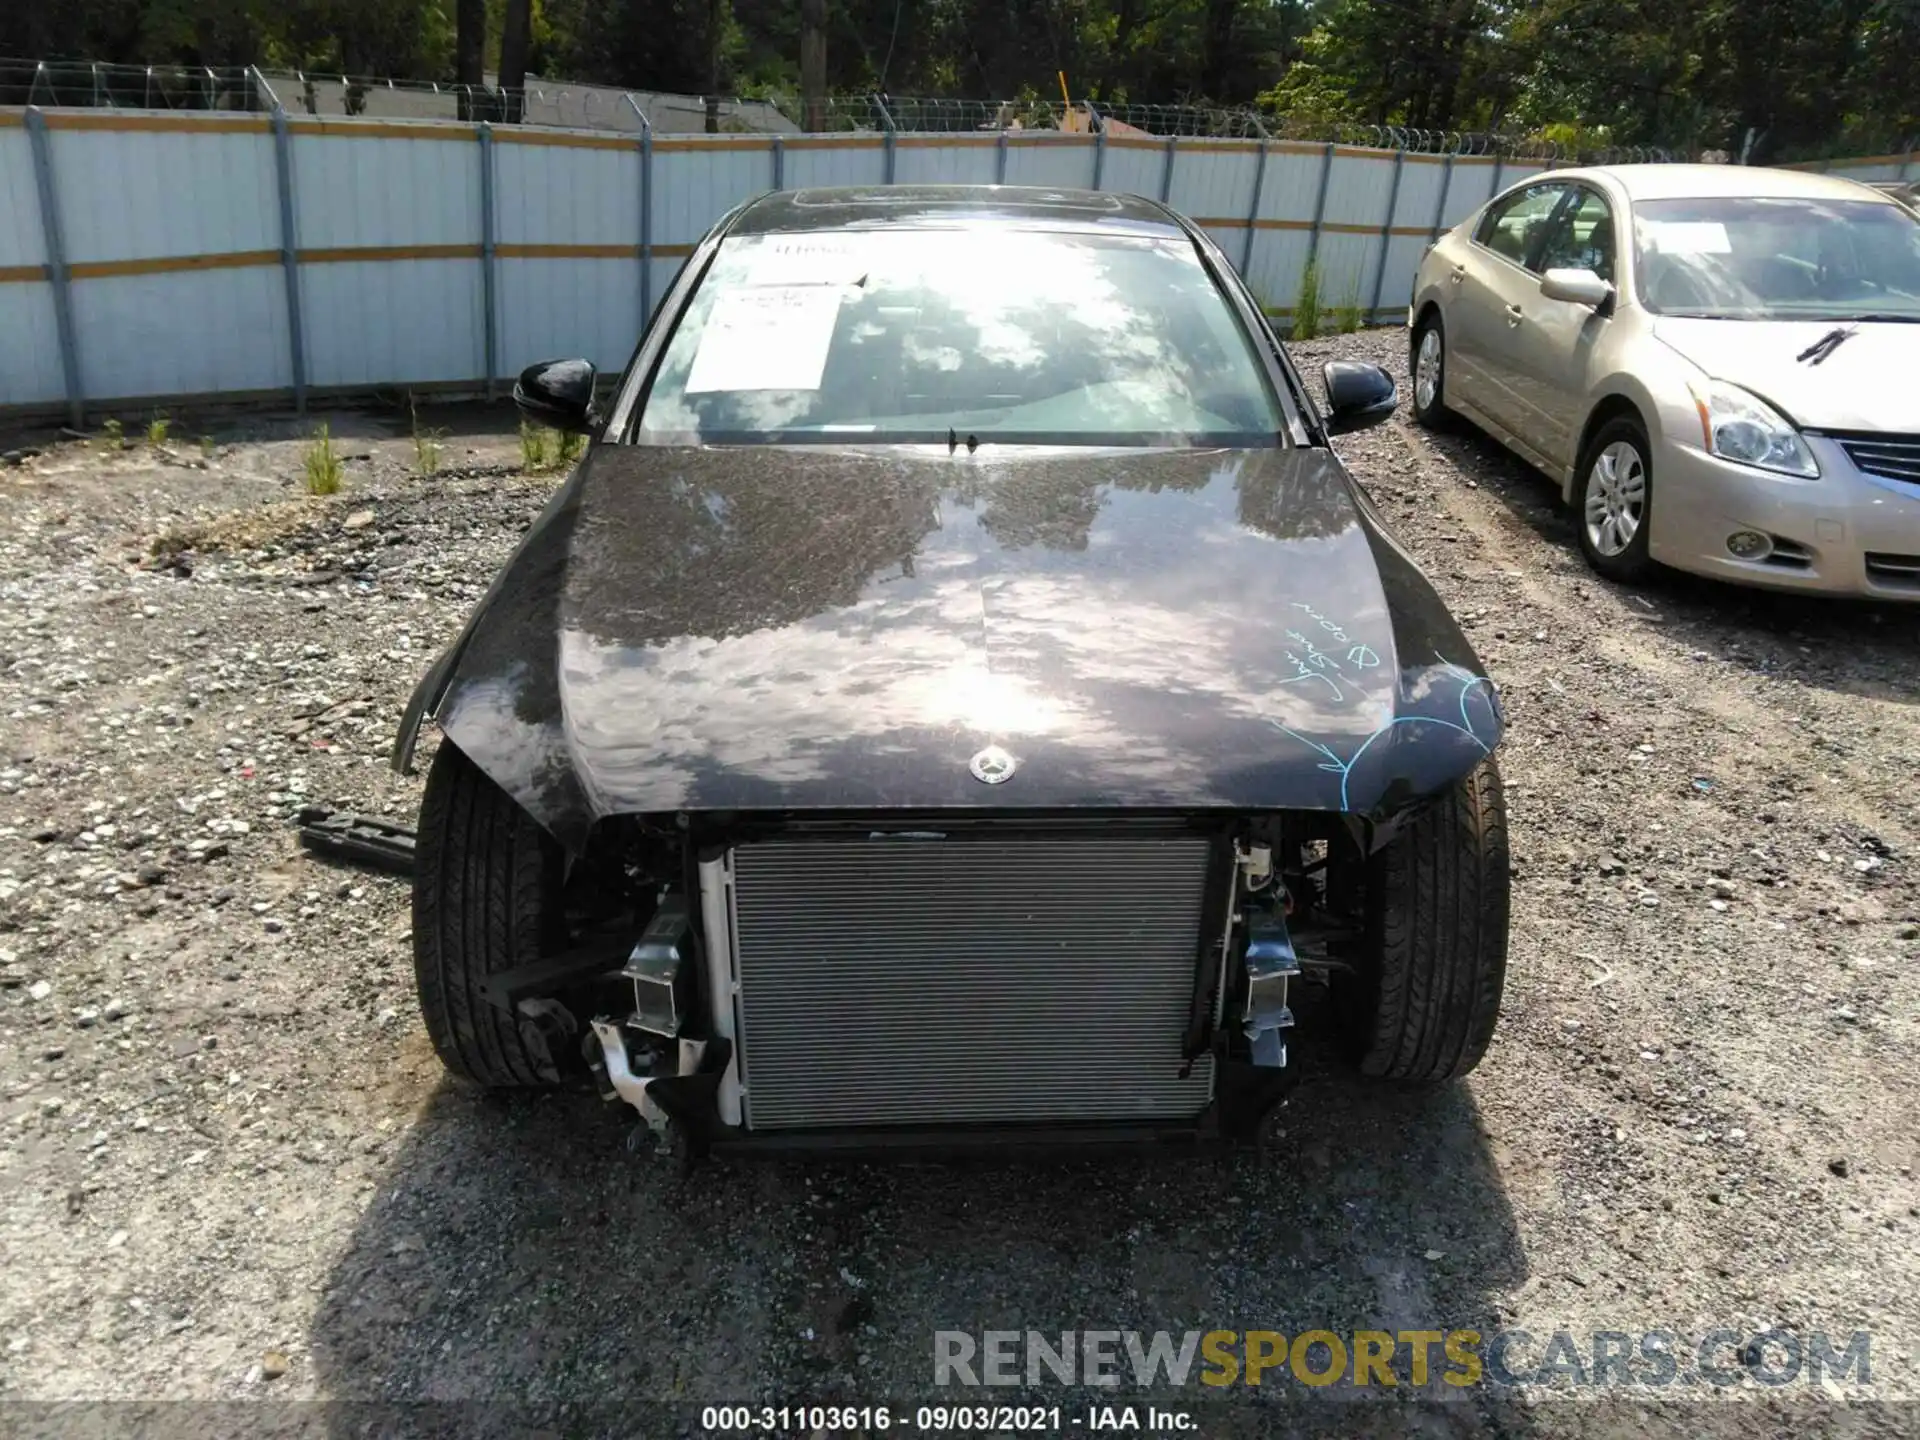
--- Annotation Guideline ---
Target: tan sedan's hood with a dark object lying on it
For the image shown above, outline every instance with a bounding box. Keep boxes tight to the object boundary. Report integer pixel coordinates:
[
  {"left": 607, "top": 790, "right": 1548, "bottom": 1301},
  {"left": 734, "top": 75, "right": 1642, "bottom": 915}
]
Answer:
[{"left": 1653, "top": 315, "right": 1920, "bottom": 430}]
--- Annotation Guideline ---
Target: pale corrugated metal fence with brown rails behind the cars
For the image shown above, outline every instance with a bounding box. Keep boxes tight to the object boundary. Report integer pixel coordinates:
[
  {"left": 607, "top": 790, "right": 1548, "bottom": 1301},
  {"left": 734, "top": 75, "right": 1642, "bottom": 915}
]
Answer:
[{"left": 0, "top": 109, "right": 1542, "bottom": 422}]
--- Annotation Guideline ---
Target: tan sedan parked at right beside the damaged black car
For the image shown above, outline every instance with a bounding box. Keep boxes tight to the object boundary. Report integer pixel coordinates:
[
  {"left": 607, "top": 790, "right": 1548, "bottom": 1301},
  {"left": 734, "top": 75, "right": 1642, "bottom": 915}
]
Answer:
[{"left": 1407, "top": 165, "right": 1920, "bottom": 599}]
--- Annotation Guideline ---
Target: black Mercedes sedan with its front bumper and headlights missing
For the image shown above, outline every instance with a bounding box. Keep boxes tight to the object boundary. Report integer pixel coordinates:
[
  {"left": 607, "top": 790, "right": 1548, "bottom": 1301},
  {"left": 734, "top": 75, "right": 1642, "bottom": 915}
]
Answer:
[{"left": 394, "top": 186, "right": 1507, "bottom": 1152}]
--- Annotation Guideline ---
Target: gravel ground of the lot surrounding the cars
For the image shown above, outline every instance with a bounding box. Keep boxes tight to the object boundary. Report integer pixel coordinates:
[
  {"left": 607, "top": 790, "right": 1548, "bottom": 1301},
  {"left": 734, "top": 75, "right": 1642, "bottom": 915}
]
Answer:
[{"left": 0, "top": 332, "right": 1920, "bottom": 1434}]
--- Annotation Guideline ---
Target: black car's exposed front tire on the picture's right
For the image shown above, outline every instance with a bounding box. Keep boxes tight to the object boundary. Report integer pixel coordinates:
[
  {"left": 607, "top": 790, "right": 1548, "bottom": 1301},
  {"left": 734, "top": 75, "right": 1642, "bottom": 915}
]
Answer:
[{"left": 1334, "top": 756, "right": 1511, "bottom": 1085}]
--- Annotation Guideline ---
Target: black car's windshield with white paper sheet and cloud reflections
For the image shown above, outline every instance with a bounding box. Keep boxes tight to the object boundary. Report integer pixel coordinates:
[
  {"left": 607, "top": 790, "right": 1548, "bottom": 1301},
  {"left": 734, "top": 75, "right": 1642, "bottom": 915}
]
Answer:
[{"left": 636, "top": 227, "right": 1284, "bottom": 445}]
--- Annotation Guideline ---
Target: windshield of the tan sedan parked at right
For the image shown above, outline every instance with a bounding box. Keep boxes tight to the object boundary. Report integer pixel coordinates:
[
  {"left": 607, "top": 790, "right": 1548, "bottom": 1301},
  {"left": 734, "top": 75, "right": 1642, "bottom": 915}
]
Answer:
[{"left": 1634, "top": 196, "right": 1920, "bottom": 321}]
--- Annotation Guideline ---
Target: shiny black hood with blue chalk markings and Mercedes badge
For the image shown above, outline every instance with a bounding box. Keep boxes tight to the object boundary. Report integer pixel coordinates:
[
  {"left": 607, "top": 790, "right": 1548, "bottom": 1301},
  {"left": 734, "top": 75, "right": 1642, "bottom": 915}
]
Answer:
[{"left": 419, "top": 445, "right": 1500, "bottom": 839}]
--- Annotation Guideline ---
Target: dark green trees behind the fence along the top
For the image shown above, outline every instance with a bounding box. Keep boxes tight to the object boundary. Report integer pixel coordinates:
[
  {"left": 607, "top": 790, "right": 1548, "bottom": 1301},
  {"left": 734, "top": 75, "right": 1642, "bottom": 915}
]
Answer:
[{"left": 0, "top": 0, "right": 1920, "bottom": 161}]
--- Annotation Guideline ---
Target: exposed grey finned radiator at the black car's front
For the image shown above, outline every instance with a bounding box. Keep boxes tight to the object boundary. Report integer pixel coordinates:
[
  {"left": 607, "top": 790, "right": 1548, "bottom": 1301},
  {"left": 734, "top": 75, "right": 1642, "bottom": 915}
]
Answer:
[{"left": 733, "top": 831, "right": 1225, "bottom": 1131}]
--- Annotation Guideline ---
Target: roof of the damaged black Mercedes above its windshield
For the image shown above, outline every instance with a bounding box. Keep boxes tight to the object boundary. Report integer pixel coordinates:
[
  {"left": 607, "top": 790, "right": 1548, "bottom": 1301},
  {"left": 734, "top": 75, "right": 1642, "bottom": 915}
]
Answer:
[{"left": 728, "top": 184, "right": 1185, "bottom": 238}]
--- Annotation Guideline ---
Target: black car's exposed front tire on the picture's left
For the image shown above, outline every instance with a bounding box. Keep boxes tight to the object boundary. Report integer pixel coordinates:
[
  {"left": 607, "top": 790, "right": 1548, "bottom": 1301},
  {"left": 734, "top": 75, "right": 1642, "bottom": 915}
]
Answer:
[{"left": 413, "top": 741, "right": 566, "bottom": 1089}]
